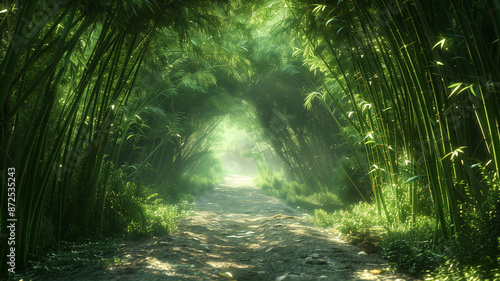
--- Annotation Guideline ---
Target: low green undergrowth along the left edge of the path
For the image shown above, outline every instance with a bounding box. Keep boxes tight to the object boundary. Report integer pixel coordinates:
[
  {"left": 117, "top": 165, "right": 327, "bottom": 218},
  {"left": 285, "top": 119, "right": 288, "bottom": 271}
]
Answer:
[{"left": 20, "top": 168, "right": 220, "bottom": 280}]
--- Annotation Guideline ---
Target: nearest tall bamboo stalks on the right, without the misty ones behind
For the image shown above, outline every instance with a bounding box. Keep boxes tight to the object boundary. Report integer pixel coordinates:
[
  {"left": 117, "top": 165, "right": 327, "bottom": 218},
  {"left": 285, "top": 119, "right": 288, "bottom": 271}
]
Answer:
[{"left": 278, "top": 1, "right": 500, "bottom": 241}]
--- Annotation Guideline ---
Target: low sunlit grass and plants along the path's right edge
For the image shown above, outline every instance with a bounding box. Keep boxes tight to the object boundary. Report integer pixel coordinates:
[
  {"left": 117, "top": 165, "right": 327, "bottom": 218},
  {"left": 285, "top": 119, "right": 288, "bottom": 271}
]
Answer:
[{"left": 256, "top": 167, "right": 500, "bottom": 281}]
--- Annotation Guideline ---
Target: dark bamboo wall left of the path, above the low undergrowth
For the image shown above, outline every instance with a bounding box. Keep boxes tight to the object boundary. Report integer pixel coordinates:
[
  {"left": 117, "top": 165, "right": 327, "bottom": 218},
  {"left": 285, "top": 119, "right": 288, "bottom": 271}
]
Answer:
[{"left": 0, "top": 1, "right": 256, "bottom": 274}]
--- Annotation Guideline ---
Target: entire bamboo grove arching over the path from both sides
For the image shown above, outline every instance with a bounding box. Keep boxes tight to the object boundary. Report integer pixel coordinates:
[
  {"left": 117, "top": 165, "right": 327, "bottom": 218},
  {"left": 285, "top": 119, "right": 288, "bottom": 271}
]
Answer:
[{"left": 0, "top": 0, "right": 500, "bottom": 273}]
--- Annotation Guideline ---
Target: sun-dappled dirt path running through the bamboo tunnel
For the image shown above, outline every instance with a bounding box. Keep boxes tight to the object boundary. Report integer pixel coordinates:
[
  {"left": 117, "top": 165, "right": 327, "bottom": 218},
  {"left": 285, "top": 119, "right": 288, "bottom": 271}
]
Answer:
[{"left": 13, "top": 176, "right": 415, "bottom": 281}]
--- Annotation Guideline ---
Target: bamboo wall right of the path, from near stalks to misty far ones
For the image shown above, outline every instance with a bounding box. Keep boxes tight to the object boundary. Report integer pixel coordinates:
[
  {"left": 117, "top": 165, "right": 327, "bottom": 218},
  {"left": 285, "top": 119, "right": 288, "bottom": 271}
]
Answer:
[{"left": 248, "top": 1, "right": 500, "bottom": 247}]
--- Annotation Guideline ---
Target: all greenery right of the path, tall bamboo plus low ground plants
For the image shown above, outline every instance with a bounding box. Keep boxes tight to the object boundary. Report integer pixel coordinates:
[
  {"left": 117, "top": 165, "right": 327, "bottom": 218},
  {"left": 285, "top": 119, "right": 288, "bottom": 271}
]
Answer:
[{"left": 248, "top": 1, "right": 500, "bottom": 280}]
